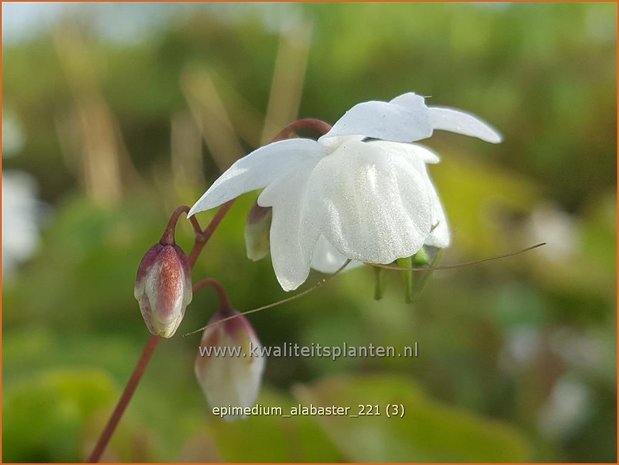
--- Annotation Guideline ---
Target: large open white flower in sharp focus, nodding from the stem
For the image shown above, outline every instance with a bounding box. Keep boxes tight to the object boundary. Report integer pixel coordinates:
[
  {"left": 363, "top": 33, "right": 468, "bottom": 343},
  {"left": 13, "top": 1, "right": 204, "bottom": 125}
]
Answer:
[{"left": 189, "top": 93, "right": 501, "bottom": 291}]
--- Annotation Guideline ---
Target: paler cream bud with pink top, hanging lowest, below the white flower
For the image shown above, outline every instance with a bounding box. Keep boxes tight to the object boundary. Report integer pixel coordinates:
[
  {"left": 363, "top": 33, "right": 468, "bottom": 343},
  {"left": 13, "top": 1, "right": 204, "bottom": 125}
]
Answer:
[{"left": 195, "top": 307, "right": 266, "bottom": 420}]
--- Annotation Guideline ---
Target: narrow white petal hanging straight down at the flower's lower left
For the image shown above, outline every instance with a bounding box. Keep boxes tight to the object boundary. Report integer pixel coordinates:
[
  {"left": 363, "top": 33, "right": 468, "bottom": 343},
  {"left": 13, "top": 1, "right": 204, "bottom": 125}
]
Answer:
[{"left": 258, "top": 159, "right": 319, "bottom": 291}]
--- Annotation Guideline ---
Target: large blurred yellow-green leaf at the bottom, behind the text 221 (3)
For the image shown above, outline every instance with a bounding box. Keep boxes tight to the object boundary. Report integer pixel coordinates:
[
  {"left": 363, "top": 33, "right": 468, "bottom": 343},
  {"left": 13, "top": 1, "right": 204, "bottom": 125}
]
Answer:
[{"left": 295, "top": 376, "right": 529, "bottom": 462}]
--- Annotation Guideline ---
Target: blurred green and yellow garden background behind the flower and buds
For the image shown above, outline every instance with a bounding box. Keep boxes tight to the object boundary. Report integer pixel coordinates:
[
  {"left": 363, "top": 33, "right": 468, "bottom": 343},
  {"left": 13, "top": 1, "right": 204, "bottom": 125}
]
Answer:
[{"left": 2, "top": 3, "right": 617, "bottom": 462}]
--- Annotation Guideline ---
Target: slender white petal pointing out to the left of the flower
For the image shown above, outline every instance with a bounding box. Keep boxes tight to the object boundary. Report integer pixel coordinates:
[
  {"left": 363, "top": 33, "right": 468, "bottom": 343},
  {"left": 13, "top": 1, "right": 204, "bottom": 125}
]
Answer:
[{"left": 188, "top": 139, "right": 326, "bottom": 216}]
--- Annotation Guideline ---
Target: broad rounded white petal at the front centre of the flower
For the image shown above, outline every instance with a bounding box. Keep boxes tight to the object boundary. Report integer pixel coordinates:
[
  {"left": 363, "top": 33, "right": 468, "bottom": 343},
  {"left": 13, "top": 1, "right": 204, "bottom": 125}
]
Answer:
[{"left": 306, "top": 141, "right": 432, "bottom": 263}]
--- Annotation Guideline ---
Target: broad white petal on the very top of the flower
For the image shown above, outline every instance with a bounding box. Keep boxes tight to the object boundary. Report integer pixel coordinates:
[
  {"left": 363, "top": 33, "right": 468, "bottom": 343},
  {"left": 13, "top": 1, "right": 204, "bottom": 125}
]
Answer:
[{"left": 319, "top": 93, "right": 432, "bottom": 142}]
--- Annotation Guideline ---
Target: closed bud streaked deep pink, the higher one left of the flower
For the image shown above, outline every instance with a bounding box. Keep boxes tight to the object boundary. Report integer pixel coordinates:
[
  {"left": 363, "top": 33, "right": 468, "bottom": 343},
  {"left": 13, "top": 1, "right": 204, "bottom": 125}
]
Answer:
[{"left": 134, "top": 244, "right": 192, "bottom": 338}]
